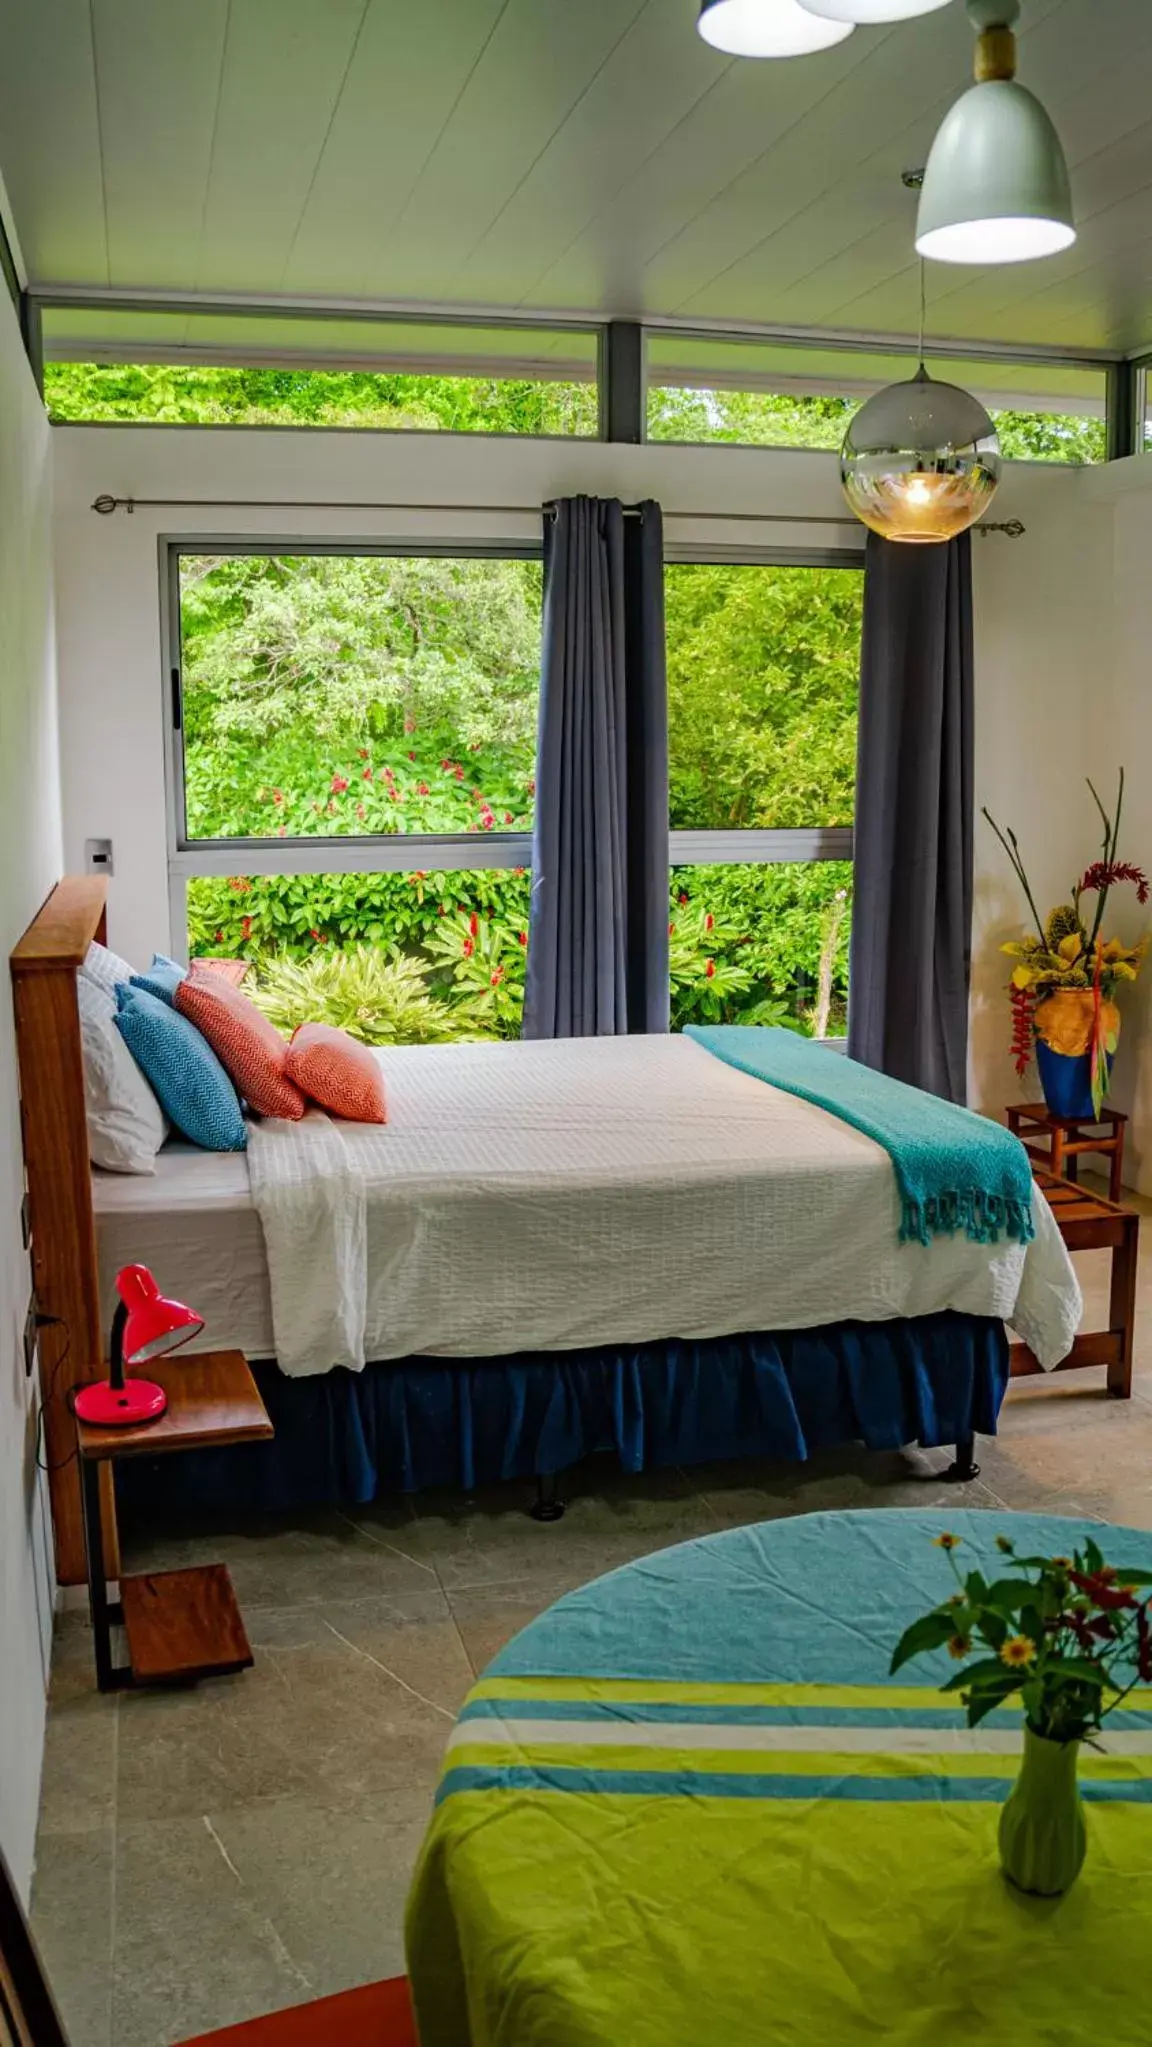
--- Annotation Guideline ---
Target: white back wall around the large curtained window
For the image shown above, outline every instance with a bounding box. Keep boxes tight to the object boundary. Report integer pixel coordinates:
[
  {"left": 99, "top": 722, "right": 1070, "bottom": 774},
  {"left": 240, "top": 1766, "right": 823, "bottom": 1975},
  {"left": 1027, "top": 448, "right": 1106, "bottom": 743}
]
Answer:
[{"left": 55, "top": 426, "right": 1088, "bottom": 1107}]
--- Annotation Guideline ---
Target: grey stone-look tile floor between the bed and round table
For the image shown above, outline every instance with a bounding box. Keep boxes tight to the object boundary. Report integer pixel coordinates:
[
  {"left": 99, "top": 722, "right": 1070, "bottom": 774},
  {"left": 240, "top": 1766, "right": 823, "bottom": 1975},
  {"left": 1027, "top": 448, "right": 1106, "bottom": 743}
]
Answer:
[{"left": 33, "top": 1204, "right": 1152, "bottom": 2047}]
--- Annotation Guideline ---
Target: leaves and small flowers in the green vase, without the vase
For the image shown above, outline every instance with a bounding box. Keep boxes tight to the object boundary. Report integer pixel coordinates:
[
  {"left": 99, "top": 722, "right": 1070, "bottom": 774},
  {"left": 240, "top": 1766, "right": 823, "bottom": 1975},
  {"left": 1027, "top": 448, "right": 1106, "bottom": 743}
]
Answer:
[{"left": 892, "top": 1533, "right": 1152, "bottom": 1742}]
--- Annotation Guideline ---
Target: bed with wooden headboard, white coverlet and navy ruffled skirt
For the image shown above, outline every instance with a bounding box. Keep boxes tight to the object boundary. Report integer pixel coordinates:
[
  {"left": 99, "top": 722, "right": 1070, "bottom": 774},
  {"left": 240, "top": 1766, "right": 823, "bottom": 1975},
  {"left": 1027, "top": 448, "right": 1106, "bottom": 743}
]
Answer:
[{"left": 12, "top": 882, "right": 1080, "bottom": 1582}]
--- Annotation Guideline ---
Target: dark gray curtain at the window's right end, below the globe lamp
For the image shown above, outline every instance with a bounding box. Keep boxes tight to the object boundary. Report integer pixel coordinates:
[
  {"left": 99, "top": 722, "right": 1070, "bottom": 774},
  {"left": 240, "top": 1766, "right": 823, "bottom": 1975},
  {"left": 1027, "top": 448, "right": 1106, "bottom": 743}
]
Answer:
[{"left": 847, "top": 532, "right": 972, "bottom": 1101}]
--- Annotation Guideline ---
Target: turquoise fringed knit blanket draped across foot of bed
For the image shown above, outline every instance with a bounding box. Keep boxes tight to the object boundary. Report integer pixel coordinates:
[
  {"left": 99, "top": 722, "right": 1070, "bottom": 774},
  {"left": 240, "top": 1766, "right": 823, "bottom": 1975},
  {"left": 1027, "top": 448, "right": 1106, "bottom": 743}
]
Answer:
[{"left": 683, "top": 1024, "right": 1035, "bottom": 1245}]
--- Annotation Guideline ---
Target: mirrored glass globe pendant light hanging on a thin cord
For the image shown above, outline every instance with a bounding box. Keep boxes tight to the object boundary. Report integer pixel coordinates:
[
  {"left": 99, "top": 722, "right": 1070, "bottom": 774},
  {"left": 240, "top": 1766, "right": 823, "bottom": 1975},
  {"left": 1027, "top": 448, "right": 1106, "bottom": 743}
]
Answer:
[{"left": 841, "top": 262, "right": 1001, "bottom": 547}]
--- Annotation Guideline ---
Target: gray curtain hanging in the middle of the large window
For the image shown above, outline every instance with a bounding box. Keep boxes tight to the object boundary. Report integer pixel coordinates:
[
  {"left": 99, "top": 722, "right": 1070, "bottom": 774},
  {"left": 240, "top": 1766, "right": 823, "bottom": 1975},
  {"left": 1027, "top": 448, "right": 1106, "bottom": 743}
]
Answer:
[{"left": 524, "top": 497, "right": 669, "bottom": 1038}]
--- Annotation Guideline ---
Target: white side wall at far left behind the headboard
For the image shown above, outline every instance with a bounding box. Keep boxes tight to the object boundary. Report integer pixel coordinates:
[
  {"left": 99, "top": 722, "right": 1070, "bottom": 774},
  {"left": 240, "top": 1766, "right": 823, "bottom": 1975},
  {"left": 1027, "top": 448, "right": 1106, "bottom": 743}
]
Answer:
[{"left": 0, "top": 291, "right": 61, "bottom": 1896}]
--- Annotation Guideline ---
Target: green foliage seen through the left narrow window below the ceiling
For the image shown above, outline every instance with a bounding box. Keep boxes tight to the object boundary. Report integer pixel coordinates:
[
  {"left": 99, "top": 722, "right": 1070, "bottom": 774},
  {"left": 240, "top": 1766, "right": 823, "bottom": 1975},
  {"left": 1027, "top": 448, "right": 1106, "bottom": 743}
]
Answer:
[{"left": 45, "top": 362, "right": 600, "bottom": 436}]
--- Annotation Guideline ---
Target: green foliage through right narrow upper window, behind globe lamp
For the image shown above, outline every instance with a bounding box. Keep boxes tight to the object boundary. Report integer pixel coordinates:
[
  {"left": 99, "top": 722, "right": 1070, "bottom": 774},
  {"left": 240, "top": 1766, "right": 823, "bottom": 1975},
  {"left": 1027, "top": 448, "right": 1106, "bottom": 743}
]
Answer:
[{"left": 649, "top": 385, "right": 1105, "bottom": 465}]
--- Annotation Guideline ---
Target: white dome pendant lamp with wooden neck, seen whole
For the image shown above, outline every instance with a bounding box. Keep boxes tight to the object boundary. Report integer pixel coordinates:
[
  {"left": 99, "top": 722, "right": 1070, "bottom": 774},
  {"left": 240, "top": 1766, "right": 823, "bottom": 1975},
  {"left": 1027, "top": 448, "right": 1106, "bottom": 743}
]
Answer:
[{"left": 917, "top": 0, "right": 1076, "bottom": 264}]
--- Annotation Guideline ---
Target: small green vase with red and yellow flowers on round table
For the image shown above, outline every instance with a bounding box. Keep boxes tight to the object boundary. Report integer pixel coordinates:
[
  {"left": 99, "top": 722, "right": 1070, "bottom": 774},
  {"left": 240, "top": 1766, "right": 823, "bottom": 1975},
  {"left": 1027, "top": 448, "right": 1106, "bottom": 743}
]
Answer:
[{"left": 892, "top": 1535, "right": 1152, "bottom": 1898}]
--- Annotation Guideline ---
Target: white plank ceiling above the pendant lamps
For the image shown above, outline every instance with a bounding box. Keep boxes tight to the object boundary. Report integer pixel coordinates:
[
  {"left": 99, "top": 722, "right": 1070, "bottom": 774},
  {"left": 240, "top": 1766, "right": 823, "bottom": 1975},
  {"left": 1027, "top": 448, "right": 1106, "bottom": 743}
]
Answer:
[{"left": 0, "top": 0, "right": 1152, "bottom": 350}]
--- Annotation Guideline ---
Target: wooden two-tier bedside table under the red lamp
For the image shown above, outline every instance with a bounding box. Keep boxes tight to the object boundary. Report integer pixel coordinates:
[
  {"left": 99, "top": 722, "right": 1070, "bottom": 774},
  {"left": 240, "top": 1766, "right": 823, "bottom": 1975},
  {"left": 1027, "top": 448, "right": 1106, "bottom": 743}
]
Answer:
[{"left": 76, "top": 1351, "right": 272, "bottom": 1691}]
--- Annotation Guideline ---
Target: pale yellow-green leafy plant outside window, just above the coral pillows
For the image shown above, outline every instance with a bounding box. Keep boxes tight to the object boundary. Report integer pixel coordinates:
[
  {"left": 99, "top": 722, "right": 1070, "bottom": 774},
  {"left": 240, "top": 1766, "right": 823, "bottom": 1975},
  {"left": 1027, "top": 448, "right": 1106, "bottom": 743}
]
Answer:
[{"left": 246, "top": 946, "right": 466, "bottom": 1044}]
